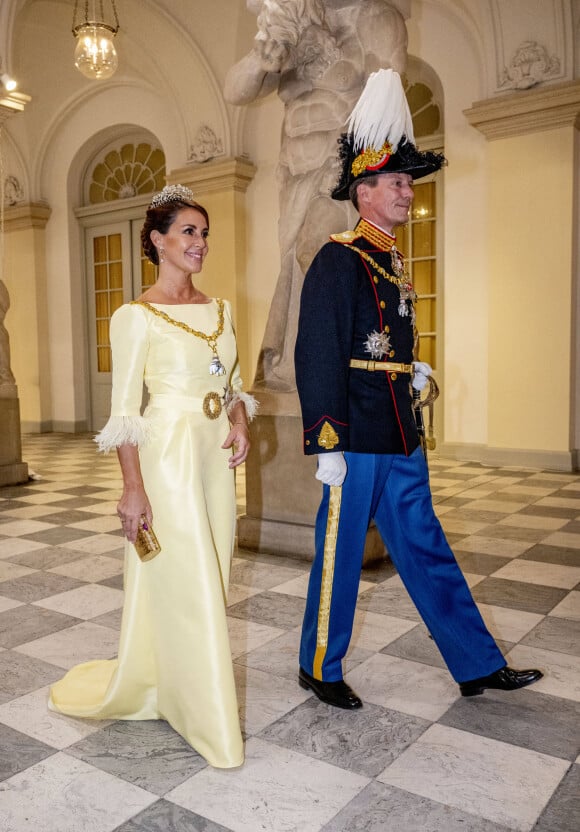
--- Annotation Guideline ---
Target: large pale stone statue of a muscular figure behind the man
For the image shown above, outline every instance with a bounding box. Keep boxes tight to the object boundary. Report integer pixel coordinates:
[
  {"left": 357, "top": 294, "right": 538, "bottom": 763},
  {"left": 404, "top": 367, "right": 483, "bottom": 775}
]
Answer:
[{"left": 225, "top": 0, "right": 407, "bottom": 392}]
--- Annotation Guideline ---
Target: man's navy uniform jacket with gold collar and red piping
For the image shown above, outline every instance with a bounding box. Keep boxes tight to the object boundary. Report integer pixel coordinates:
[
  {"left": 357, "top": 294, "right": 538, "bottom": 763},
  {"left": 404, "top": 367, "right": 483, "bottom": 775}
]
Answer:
[{"left": 295, "top": 220, "right": 419, "bottom": 456}]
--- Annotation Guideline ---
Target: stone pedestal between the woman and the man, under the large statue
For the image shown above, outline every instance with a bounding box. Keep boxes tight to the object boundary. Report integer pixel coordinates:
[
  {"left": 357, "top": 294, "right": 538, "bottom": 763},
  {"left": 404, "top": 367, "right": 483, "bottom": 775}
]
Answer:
[{"left": 238, "top": 390, "right": 385, "bottom": 563}]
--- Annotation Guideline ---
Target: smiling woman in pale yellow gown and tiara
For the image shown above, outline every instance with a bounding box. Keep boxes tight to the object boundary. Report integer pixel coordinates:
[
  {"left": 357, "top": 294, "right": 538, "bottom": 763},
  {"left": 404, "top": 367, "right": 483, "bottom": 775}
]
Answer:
[{"left": 49, "top": 185, "right": 256, "bottom": 768}]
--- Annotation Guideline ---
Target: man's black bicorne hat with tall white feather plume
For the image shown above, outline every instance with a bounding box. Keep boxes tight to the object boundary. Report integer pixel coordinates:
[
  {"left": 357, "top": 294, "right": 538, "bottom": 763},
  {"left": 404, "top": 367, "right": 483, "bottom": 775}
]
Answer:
[{"left": 332, "top": 69, "right": 445, "bottom": 199}]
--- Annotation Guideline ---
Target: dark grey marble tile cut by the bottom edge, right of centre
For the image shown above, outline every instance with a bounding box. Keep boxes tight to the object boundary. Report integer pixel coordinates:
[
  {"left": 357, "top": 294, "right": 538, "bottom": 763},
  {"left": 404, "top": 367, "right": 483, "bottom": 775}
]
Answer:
[{"left": 320, "top": 782, "right": 516, "bottom": 832}]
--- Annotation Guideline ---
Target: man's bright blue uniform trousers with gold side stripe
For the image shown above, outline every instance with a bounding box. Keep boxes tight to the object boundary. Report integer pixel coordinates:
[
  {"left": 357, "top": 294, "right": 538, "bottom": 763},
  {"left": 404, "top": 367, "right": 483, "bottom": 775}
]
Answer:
[{"left": 300, "top": 448, "right": 506, "bottom": 682}]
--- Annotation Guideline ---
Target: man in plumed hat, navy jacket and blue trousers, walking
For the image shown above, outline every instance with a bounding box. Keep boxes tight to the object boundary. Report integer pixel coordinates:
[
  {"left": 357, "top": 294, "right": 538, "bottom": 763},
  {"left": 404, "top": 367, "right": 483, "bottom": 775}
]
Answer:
[{"left": 295, "top": 70, "right": 542, "bottom": 708}]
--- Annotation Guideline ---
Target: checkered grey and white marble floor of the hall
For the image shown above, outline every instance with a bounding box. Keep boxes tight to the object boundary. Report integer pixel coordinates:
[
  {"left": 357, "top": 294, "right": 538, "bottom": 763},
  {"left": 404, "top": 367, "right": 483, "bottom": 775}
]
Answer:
[{"left": 0, "top": 434, "right": 580, "bottom": 832}]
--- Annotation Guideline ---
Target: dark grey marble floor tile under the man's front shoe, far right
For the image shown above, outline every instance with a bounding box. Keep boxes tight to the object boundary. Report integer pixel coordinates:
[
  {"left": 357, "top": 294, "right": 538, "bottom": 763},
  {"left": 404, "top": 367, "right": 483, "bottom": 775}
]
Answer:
[{"left": 439, "top": 686, "right": 580, "bottom": 760}]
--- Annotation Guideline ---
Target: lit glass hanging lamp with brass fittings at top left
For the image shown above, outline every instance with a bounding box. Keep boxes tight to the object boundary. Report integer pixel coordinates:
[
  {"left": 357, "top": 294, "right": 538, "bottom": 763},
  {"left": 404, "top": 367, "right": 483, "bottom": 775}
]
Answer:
[{"left": 72, "top": 0, "right": 119, "bottom": 80}]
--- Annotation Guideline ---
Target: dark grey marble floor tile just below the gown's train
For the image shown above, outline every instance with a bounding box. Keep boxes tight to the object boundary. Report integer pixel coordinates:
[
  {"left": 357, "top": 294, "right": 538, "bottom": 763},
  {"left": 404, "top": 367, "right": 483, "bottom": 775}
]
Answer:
[{"left": 66, "top": 720, "right": 207, "bottom": 796}]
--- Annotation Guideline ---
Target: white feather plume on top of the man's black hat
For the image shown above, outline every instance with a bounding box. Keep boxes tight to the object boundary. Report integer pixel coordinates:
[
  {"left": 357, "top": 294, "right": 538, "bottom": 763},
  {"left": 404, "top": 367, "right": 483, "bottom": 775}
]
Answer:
[{"left": 347, "top": 69, "right": 415, "bottom": 152}]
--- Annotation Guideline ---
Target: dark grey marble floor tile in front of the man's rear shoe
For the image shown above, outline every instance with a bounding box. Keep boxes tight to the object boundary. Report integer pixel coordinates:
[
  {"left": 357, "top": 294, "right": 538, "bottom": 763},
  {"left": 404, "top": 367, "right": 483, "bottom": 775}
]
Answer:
[{"left": 258, "top": 699, "right": 431, "bottom": 777}]
